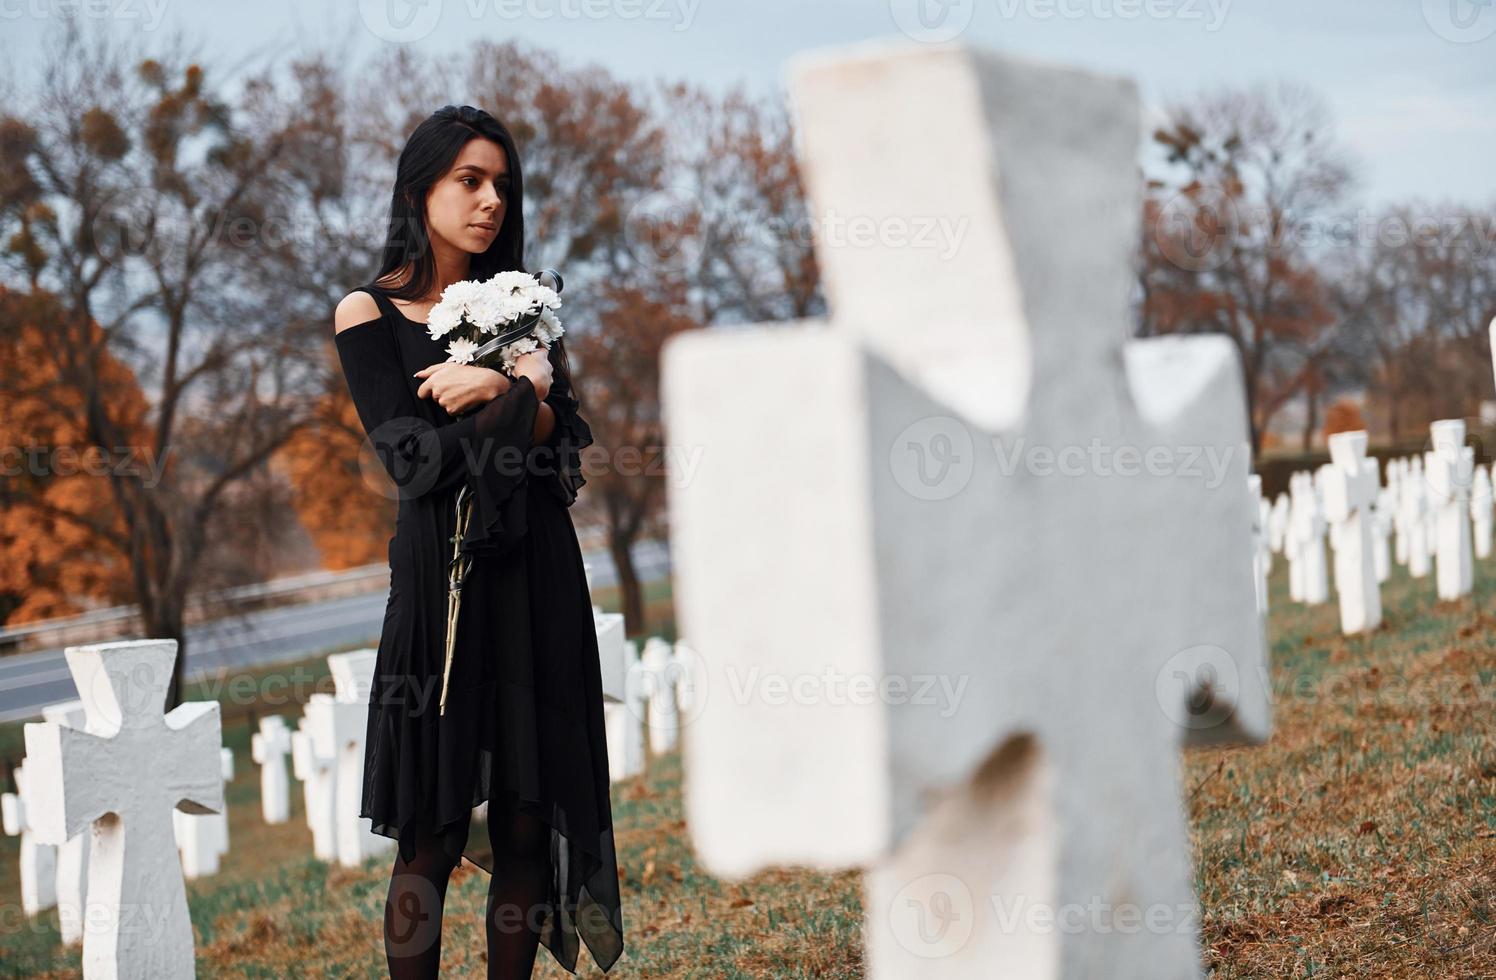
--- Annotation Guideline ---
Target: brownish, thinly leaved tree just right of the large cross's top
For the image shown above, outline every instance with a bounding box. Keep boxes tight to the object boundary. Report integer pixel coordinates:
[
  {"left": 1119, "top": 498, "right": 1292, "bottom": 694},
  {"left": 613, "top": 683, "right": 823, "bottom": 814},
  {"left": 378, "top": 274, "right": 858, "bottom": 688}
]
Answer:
[{"left": 1140, "top": 84, "right": 1351, "bottom": 450}]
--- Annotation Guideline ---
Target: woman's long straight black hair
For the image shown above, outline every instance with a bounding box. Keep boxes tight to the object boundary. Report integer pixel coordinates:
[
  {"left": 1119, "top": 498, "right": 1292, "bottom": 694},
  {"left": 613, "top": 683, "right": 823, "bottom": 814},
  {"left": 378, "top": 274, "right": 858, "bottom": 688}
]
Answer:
[{"left": 371, "top": 105, "right": 580, "bottom": 409}]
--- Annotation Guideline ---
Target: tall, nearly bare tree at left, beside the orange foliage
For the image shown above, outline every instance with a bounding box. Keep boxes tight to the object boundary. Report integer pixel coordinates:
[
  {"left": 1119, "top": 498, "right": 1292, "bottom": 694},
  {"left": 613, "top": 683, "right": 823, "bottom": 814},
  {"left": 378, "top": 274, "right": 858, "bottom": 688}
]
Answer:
[{"left": 0, "top": 27, "right": 333, "bottom": 708}]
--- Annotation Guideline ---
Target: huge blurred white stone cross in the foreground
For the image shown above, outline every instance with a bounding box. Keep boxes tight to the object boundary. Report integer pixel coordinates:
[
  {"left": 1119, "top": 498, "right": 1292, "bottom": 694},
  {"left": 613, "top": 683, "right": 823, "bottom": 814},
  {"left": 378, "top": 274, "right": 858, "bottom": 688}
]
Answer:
[{"left": 663, "top": 43, "right": 1270, "bottom": 980}]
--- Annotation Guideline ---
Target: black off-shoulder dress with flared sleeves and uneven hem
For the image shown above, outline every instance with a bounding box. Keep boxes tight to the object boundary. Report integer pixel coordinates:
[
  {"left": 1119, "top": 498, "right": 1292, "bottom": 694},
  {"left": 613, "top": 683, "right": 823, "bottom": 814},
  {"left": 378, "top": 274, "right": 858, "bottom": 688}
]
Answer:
[{"left": 334, "top": 286, "right": 624, "bottom": 973}]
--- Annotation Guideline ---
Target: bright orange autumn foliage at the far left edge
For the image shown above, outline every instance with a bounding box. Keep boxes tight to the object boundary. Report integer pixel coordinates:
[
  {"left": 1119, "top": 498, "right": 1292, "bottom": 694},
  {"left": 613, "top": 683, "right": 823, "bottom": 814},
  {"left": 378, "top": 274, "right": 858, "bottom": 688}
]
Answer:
[{"left": 0, "top": 287, "right": 142, "bottom": 625}]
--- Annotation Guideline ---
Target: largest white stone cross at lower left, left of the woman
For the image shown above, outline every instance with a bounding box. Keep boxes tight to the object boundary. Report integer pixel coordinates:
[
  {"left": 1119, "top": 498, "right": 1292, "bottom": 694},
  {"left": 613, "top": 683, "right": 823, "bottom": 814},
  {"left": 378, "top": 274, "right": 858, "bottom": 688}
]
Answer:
[{"left": 25, "top": 640, "right": 223, "bottom": 979}]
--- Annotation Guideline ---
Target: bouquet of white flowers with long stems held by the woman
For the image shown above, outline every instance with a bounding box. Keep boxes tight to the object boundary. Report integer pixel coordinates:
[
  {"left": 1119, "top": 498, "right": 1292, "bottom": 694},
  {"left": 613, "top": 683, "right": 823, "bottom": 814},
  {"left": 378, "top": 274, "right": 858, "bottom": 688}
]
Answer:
[{"left": 439, "top": 269, "right": 565, "bottom": 715}]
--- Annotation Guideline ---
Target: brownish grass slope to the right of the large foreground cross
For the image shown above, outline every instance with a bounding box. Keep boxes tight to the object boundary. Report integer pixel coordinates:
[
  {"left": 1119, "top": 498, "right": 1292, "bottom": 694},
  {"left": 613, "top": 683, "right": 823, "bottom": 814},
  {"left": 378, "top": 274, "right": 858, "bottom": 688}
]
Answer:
[{"left": 1183, "top": 557, "right": 1496, "bottom": 980}]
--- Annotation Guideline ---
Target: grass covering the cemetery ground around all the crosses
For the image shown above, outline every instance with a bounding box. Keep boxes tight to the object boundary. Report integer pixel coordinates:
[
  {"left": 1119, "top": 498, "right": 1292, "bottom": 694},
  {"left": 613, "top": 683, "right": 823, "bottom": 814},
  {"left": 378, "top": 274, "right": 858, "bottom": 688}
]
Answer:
[{"left": 0, "top": 561, "right": 1496, "bottom": 980}]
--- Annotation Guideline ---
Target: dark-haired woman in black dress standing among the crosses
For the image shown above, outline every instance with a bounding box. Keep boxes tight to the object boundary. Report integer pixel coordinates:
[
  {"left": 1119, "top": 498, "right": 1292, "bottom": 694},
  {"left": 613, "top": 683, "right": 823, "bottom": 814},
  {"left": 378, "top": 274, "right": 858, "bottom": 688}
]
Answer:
[{"left": 334, "top": 106, "right": 624, "bottom": 980}]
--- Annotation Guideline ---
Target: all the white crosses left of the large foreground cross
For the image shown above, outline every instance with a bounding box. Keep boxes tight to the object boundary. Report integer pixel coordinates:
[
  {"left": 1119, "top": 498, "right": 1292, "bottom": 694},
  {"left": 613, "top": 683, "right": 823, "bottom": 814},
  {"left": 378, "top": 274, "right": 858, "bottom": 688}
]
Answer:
[{"left": 0, "top": 598, "right": 646, "bottom": 979}]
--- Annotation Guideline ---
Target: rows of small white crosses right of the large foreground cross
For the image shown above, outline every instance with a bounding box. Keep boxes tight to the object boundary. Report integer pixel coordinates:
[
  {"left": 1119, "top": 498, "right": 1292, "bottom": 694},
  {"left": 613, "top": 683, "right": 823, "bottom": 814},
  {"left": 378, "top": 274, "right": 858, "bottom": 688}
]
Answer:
[{"left": 1267, "top": 419, "right": 1493, "bottom": 634}]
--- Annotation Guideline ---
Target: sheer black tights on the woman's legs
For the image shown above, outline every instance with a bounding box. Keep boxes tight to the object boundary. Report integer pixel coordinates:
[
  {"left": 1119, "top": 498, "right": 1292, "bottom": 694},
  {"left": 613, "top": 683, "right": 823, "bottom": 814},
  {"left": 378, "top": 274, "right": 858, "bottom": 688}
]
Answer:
[{"left": 384, "top": 803, "right": 551, "bottom": 980}]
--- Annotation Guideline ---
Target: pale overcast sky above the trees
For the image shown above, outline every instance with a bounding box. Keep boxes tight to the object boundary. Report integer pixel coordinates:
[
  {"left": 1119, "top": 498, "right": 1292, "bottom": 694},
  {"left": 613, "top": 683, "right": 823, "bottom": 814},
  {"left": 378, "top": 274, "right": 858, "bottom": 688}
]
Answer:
[{"left": 0, "top": 0, "right": 1496, "bottom": 206}]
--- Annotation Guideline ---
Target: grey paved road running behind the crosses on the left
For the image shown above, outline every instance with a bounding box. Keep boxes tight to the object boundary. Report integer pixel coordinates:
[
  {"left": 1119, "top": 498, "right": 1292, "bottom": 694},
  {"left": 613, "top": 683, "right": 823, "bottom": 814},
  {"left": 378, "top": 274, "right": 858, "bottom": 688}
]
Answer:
[{"left": 0, "top": 542, "right": 670, "bottom": 721}]
